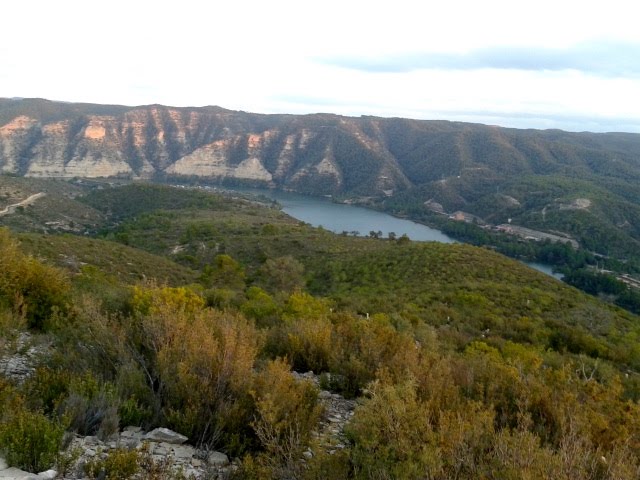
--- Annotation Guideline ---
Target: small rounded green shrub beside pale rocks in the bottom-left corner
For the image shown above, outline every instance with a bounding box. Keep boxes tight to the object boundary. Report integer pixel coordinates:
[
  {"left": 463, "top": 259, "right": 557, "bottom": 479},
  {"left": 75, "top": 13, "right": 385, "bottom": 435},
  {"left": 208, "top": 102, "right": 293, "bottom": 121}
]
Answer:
[{"left": 0, "top": 409, "right": 65, "bottom": 472}]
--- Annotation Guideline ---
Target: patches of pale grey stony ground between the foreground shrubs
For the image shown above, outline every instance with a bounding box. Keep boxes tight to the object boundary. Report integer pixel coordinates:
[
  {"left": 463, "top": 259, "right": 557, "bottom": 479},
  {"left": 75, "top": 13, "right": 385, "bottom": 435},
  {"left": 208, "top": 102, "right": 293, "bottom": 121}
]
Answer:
[{"left": 0, "top": 335, "right": 356, "bottom": 480}]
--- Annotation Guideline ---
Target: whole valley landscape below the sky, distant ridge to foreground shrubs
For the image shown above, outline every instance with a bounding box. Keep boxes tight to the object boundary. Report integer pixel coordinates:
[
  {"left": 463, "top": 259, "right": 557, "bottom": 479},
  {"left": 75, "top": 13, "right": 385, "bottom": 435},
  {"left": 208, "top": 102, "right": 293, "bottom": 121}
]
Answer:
[{"left": 0, "top": 99, "right": 640, "bottom": 480}]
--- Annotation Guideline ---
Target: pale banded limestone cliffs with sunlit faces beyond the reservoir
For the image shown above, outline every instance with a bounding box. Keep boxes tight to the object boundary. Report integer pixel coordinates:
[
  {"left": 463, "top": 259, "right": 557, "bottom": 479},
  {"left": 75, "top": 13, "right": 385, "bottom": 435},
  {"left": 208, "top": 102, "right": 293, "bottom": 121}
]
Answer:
[{"left": 0, "top": 99, "right": 409, "bottom": 193}]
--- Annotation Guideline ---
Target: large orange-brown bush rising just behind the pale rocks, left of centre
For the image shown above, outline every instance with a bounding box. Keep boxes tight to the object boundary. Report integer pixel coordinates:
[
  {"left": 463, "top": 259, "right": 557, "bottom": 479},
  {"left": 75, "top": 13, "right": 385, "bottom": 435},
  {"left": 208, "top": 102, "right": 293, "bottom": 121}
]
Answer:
[{"left": 131, "top": 295, "right": 261, "bottom": 452}]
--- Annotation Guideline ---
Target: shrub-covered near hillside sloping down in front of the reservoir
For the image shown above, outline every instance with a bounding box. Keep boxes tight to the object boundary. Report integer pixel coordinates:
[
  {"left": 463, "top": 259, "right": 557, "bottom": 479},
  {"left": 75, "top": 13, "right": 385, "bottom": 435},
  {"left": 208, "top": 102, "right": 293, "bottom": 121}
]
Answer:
[{"left": 0, "top": 179, "right": 640, "bottom": 480}]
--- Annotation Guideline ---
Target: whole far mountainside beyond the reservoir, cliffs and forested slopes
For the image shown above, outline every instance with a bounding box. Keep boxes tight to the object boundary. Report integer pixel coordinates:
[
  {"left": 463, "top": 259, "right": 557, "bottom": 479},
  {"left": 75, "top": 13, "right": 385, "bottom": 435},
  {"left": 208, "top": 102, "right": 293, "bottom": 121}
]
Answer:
[{"left": 0, "top": 95, "right": 640, "bottom": 256}]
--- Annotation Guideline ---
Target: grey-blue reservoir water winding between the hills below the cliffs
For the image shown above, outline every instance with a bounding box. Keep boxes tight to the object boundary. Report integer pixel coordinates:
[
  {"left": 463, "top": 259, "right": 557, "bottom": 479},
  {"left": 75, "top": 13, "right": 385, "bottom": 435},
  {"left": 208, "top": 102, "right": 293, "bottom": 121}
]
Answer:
[{"left": 228, "top": 189, "right": 562, "bottom": 280}]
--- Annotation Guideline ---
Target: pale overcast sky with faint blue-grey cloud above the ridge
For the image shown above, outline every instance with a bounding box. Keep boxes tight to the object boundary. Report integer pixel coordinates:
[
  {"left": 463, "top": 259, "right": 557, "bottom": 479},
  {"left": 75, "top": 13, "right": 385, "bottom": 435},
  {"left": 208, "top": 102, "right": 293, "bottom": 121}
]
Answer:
[{"left": 0, "top": 0, "right": 640, "bottom": 132}]
